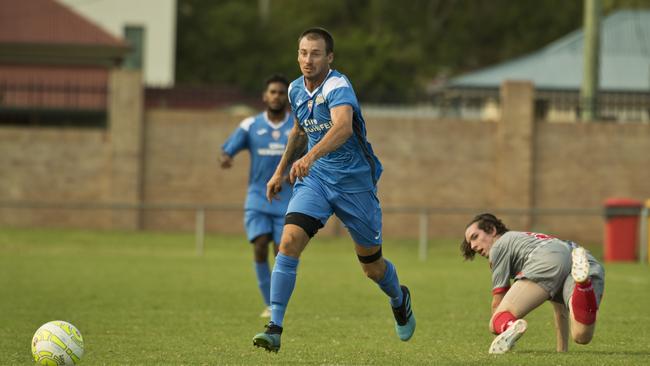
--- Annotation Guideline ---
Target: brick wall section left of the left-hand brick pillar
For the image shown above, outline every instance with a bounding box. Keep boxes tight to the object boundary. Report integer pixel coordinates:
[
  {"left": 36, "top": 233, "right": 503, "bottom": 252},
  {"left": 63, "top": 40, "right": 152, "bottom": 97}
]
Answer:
[{"left": 0, "top": 127, "right": 111, "bottom": 228}]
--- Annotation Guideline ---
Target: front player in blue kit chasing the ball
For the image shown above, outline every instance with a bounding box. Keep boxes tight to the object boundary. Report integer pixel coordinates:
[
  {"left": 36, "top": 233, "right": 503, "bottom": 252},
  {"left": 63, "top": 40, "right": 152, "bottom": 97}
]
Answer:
[{"left": 253, "top": 28, "right": 415, "bottom": 352}]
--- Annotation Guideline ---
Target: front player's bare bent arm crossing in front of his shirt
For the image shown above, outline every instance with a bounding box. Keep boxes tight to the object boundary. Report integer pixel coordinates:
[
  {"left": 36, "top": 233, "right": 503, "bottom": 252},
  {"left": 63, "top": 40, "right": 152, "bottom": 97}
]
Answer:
[{"left": 289, "top": 104, "right": 353, "bottom": 182}]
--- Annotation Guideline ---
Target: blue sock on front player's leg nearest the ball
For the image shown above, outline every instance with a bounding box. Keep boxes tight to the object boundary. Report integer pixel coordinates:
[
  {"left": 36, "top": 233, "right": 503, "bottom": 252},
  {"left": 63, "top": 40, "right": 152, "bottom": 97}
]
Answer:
[{"left": 271, "top": 253, "right": 298, "bottom": 327}]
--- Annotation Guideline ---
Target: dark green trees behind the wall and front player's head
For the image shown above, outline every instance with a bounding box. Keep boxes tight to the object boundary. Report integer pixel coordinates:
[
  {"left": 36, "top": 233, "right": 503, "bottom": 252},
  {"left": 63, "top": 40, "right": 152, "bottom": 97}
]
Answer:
[{"left": 177, "top": 0, "right": 650, "bottom": 102}]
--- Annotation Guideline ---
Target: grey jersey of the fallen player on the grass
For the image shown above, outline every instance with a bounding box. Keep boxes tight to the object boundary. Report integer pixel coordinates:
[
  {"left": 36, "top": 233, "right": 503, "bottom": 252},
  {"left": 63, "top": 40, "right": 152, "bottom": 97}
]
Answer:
[{"left": 489, "top": 231, "right": 560, "bottom": 294}]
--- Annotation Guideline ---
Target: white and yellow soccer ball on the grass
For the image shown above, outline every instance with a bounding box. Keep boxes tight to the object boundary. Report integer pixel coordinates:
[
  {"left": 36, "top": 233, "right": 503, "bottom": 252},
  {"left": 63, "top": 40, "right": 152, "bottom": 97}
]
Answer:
[{"left": 32, "top": 320, "right": 84, "bottom": 366}]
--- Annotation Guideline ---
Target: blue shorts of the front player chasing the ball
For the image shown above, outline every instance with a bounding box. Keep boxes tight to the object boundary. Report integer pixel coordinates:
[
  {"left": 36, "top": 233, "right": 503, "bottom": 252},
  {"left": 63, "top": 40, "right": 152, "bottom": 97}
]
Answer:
[{"left": 287, "top": 176, "right": 382, "bottom": 247}]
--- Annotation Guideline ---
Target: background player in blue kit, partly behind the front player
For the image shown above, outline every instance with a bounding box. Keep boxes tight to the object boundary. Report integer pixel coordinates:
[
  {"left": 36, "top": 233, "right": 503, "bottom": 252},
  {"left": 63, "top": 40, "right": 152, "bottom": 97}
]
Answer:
[{"left": 219, "top": 75, "right": 293, "bottom": 318}]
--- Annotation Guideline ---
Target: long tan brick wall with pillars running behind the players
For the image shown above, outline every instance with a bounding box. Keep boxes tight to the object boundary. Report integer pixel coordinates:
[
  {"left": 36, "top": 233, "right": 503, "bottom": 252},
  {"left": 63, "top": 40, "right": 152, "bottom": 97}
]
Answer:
[{"left": 0, "top": 78, "right": 650, "bottom": 243}]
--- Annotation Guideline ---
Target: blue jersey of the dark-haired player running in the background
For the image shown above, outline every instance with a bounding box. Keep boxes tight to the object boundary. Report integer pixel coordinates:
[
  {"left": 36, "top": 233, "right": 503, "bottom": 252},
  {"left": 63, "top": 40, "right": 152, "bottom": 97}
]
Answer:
[{"left": 222, "top": 112, "right": 293, "bottom": 215}]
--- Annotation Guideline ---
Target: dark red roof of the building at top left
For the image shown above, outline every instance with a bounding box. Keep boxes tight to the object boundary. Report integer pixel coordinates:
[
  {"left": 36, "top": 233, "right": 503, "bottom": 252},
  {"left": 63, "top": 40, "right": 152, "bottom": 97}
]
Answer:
[{"left": 0, "top": 0, "right": 126, "bottom": 48}]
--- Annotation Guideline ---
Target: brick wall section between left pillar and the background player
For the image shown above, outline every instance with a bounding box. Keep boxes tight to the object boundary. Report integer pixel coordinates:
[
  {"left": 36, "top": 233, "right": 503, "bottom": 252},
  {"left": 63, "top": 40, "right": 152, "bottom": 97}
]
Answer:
[{"left": 143, "top": 110, "right": 248, "bottom": 233}]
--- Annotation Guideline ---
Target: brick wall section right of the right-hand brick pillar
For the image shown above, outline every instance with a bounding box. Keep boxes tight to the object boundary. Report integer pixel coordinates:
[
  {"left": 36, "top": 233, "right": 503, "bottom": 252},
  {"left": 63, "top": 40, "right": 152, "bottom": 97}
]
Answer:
[{"left": 533, "top": 123, "right": 650, "bottom": 242}]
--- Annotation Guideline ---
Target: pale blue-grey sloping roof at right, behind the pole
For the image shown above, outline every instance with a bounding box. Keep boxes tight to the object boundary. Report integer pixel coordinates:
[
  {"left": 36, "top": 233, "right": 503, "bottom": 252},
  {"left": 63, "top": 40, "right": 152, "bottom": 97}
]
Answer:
[{"left": 449, "top": 10, "right": 650, "bottom": 91}]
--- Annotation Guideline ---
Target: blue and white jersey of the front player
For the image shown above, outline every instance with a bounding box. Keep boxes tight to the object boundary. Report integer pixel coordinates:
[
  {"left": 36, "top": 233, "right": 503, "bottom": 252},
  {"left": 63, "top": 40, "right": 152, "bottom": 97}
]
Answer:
[{"left": 288, "top": 70, "right": 382, "bottom": 193}]
